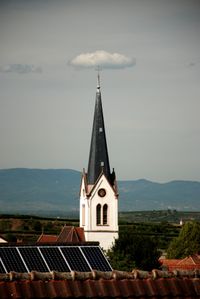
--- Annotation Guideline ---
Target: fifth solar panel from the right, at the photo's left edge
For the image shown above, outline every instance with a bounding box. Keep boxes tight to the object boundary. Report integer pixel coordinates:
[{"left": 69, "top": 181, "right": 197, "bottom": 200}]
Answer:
[{"left": 0, "top": 247, "right": 27, "bottom": 273}]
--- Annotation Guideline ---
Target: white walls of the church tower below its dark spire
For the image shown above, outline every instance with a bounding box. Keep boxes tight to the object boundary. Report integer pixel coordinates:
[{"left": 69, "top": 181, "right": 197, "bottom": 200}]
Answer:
[{"left": 80, "top": 174, "right": 118, "bottom": 250}]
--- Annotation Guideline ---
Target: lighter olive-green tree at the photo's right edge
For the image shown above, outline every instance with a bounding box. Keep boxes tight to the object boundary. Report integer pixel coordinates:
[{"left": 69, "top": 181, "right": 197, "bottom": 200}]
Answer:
[{"left": 167, "top": 221, "right": 200, "bottom": 259}]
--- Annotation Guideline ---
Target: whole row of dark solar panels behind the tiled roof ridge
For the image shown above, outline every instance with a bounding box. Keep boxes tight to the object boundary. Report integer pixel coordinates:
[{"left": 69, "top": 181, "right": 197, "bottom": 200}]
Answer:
[{"left": 0, "top": 246, "right": 112, "bottom": 273}]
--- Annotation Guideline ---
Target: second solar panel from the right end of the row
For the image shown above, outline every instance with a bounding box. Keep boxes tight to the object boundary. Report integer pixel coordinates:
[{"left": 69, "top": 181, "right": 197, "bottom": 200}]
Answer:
[{"left": 61, "top": 246, "right": 91, "bottom": 272}]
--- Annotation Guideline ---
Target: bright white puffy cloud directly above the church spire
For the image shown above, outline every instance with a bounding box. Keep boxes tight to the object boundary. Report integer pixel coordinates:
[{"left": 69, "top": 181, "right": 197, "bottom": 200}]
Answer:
[{"left": 69, "top": 50, "right": 135, "bottom": 69}]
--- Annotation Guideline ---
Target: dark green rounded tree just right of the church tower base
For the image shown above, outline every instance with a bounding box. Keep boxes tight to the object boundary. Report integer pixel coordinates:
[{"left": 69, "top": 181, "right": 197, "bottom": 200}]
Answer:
[{"left": 107, "top": 229, "right": 160, "bottom": 271}]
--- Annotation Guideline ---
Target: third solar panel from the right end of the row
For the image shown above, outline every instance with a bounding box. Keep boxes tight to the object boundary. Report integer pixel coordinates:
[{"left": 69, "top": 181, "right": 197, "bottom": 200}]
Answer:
[{"left": 40, "top": 247, "right": 70, "bottom": 272}]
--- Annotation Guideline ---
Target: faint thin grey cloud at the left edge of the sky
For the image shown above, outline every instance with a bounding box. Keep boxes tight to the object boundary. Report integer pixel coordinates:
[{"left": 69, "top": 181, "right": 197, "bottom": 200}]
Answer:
[{"left": 0, "top": 63, "right": 42, "bottom": 74}]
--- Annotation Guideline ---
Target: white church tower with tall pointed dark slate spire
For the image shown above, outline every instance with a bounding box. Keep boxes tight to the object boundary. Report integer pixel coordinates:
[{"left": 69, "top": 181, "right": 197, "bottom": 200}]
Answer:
[{"left": 80, "top": 74, "right": 118, "bottom": 250}]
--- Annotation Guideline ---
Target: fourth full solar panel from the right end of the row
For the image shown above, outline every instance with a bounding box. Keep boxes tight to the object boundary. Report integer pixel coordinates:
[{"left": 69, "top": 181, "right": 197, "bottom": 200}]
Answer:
[{"left": 19, "top": 247, "right": 49, "bottom": 272}]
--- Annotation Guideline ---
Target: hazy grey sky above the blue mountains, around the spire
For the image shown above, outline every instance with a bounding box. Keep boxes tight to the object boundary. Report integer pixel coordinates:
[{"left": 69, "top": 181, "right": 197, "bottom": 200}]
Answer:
[{"left": 0, "top": 0, "right": 200, "bottom": 182}]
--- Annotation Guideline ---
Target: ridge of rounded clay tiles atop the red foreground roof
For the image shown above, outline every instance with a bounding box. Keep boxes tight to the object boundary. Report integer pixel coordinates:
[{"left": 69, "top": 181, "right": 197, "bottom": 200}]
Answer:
[{"left": 0, "top": 270, "right": 200, "bottom": 281}]
